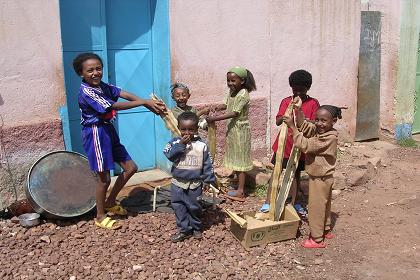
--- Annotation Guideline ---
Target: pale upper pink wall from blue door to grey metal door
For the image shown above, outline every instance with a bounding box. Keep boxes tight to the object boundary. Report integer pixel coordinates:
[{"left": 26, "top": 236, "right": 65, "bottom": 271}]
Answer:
[{"left": 170, "top": 0, "right": 360, "bottom": 160}]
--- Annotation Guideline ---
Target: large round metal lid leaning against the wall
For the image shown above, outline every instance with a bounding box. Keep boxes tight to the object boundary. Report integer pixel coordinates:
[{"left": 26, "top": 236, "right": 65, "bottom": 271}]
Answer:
[{"left": 26, "top": 151, "right": 98, "bottom": 218}]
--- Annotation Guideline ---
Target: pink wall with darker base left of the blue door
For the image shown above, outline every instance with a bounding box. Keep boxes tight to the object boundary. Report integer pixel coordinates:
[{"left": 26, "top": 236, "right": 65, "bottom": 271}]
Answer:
[{"left": 0, "top": 0, "right": 65, "bottom": 209}]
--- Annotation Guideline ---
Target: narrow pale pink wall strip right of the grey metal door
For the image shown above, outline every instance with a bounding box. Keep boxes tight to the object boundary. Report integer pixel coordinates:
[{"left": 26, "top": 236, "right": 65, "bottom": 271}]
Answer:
[{"left": 362, "top": 0, "right": 400, "bottom": 132}]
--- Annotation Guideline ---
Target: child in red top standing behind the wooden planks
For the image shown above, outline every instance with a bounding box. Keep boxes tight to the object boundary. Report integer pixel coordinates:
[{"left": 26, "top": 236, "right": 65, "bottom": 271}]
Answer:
[{"left": 260, "top": 70, "right": 319, "bottom": 212}]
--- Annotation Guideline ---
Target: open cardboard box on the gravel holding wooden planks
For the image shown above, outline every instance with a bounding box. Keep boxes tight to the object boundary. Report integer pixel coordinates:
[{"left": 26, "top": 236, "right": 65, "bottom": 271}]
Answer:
[{"left": 230, "top": 204, "right": 300, "bottom": 248}]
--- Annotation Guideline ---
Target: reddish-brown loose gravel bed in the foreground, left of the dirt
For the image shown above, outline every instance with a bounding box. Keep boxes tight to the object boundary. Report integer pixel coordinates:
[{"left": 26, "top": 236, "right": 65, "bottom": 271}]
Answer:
[{"left": 0, "top": 197, "right": 302, "bottom": 279}]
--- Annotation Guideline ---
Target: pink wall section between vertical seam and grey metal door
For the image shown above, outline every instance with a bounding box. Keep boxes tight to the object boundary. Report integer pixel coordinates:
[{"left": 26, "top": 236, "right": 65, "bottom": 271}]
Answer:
[{"left": 269, "top": 0, "right": 360, "bottom": 140}]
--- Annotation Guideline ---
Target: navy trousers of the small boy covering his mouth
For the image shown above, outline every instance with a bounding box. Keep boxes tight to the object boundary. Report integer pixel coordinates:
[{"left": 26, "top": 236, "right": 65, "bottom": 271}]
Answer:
[{"left": 171, "top": 184, "right": 203, "bottom": 233}]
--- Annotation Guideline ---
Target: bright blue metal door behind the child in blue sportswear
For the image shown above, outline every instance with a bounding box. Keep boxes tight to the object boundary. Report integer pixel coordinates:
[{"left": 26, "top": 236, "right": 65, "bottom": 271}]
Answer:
[{"left": 60, "top": 0, "right": 170, "bottom": 170}]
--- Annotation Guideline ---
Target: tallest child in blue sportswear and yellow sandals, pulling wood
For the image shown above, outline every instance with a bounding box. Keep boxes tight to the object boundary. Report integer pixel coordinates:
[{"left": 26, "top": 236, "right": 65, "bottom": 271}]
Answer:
[{"left": 73, "top": 53, "right": 165, "bottom": 229}]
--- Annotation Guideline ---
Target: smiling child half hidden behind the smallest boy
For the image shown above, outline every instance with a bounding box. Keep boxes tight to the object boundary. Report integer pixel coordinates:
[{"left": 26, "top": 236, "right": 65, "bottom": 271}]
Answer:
[{"left": 171, "top": 83, "right": 209, "bottom": 119}]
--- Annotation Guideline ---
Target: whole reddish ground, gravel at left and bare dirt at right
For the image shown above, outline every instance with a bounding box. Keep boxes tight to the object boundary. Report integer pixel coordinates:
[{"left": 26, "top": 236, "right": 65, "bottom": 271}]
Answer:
[{"left": 0, "top": 137, "right": 420, "bottom": 280}]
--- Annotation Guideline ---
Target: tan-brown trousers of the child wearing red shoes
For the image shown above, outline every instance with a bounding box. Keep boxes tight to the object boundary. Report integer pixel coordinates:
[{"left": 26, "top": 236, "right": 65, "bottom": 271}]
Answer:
[{"left": 308, "top": 176, "right": 334, "bottom": 242}]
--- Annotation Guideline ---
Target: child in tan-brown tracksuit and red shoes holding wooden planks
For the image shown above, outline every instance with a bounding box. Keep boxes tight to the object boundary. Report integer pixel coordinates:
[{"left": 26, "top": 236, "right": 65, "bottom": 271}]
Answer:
[{"left": 284, "top": 105, "right": 341, "bottom": 248}]
